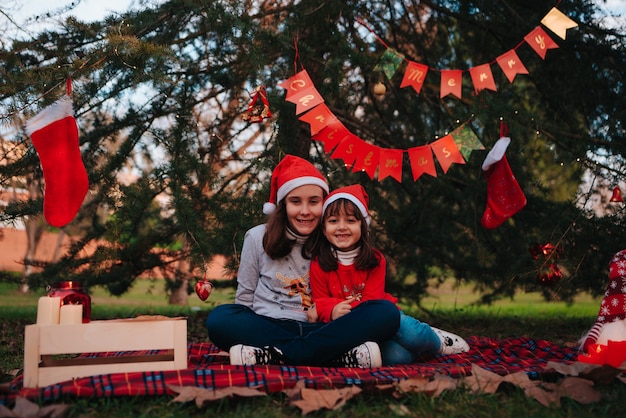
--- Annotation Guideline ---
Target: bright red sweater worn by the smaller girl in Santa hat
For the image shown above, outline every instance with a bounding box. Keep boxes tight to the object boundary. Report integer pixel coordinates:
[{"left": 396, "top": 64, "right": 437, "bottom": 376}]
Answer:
[{"left": 310, "top": 250, "right": 398, "bottom": 322}]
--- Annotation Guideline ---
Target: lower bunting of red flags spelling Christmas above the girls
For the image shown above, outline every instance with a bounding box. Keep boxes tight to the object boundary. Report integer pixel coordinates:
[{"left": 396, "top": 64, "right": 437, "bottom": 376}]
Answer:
[{"left": 279, "top": 70, "right": 485, "bottom": 182}]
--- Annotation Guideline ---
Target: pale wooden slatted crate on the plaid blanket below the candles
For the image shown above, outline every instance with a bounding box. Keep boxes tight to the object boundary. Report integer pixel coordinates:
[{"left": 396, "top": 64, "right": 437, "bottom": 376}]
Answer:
[{"left": 24, "top": 317, "right": 187, "bottom": 388}]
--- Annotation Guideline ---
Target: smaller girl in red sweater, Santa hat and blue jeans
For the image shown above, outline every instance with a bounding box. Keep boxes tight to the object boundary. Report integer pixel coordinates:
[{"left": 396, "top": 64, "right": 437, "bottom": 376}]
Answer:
[{"left": 311, "top": 184, "right": 469, "bottom": 365}]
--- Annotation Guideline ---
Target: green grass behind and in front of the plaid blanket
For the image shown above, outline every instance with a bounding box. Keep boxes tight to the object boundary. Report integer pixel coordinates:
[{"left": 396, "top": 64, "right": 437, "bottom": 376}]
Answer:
[{"left": 0, "top": 280, "right": 626, "bottom": 418}]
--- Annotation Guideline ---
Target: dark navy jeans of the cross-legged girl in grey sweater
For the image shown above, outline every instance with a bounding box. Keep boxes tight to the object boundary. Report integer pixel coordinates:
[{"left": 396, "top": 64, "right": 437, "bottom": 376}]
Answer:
[{"left": 206, "top": 300, "right": 400, "bottom": 366}]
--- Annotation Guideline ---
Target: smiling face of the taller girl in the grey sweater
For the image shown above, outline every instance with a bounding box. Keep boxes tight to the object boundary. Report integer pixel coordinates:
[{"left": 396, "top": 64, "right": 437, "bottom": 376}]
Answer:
[{"left": 285, "top": 184, "right": 324, "bottom": 236}]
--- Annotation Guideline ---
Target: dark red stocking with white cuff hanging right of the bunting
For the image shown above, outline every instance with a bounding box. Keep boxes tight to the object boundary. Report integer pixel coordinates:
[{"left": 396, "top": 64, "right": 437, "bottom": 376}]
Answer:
[{"left": 481, "top": 137, "right": 526, "bottom": 229}]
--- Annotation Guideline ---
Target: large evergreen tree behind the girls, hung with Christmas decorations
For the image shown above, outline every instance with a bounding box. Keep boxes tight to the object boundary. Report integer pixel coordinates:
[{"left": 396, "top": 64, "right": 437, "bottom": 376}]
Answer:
[{"left": 0, "top": 0, "right": 626, "bottom": 303}]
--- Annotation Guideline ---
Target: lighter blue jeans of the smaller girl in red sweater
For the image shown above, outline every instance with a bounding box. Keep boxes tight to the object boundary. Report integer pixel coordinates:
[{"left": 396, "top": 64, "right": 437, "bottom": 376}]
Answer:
[{"left": 380, "top": 312, "right": 441, "bottom": 366}]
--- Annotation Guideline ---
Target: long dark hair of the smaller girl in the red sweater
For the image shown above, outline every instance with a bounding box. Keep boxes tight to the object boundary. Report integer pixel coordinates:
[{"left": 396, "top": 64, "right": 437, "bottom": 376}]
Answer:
[{"left": 305, "top": 199, "right": 380, "bottom": 271}]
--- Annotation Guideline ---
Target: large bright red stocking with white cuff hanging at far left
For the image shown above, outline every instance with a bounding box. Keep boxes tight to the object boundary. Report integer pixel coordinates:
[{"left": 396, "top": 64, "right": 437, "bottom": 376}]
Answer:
[{"left": 26, "top": 96, "right": 89, "bottom": 228}]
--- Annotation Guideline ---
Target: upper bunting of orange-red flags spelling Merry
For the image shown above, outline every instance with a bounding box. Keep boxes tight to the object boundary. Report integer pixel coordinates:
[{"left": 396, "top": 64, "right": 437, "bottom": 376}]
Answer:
[{"left": 358, "top": 7, "right": 578, "bottom": 99}]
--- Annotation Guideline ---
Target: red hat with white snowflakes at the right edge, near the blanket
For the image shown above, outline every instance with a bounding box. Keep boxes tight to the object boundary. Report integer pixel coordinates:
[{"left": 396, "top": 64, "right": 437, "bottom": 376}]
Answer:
[{"left": 582, "top": 250, "right": 626, "bottom": 351}]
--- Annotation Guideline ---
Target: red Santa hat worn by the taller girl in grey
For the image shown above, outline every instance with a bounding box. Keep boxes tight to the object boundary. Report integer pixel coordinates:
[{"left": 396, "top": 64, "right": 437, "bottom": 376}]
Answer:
[{"left": 263, "top": 154, "right": 328, "bottom": 215}]
